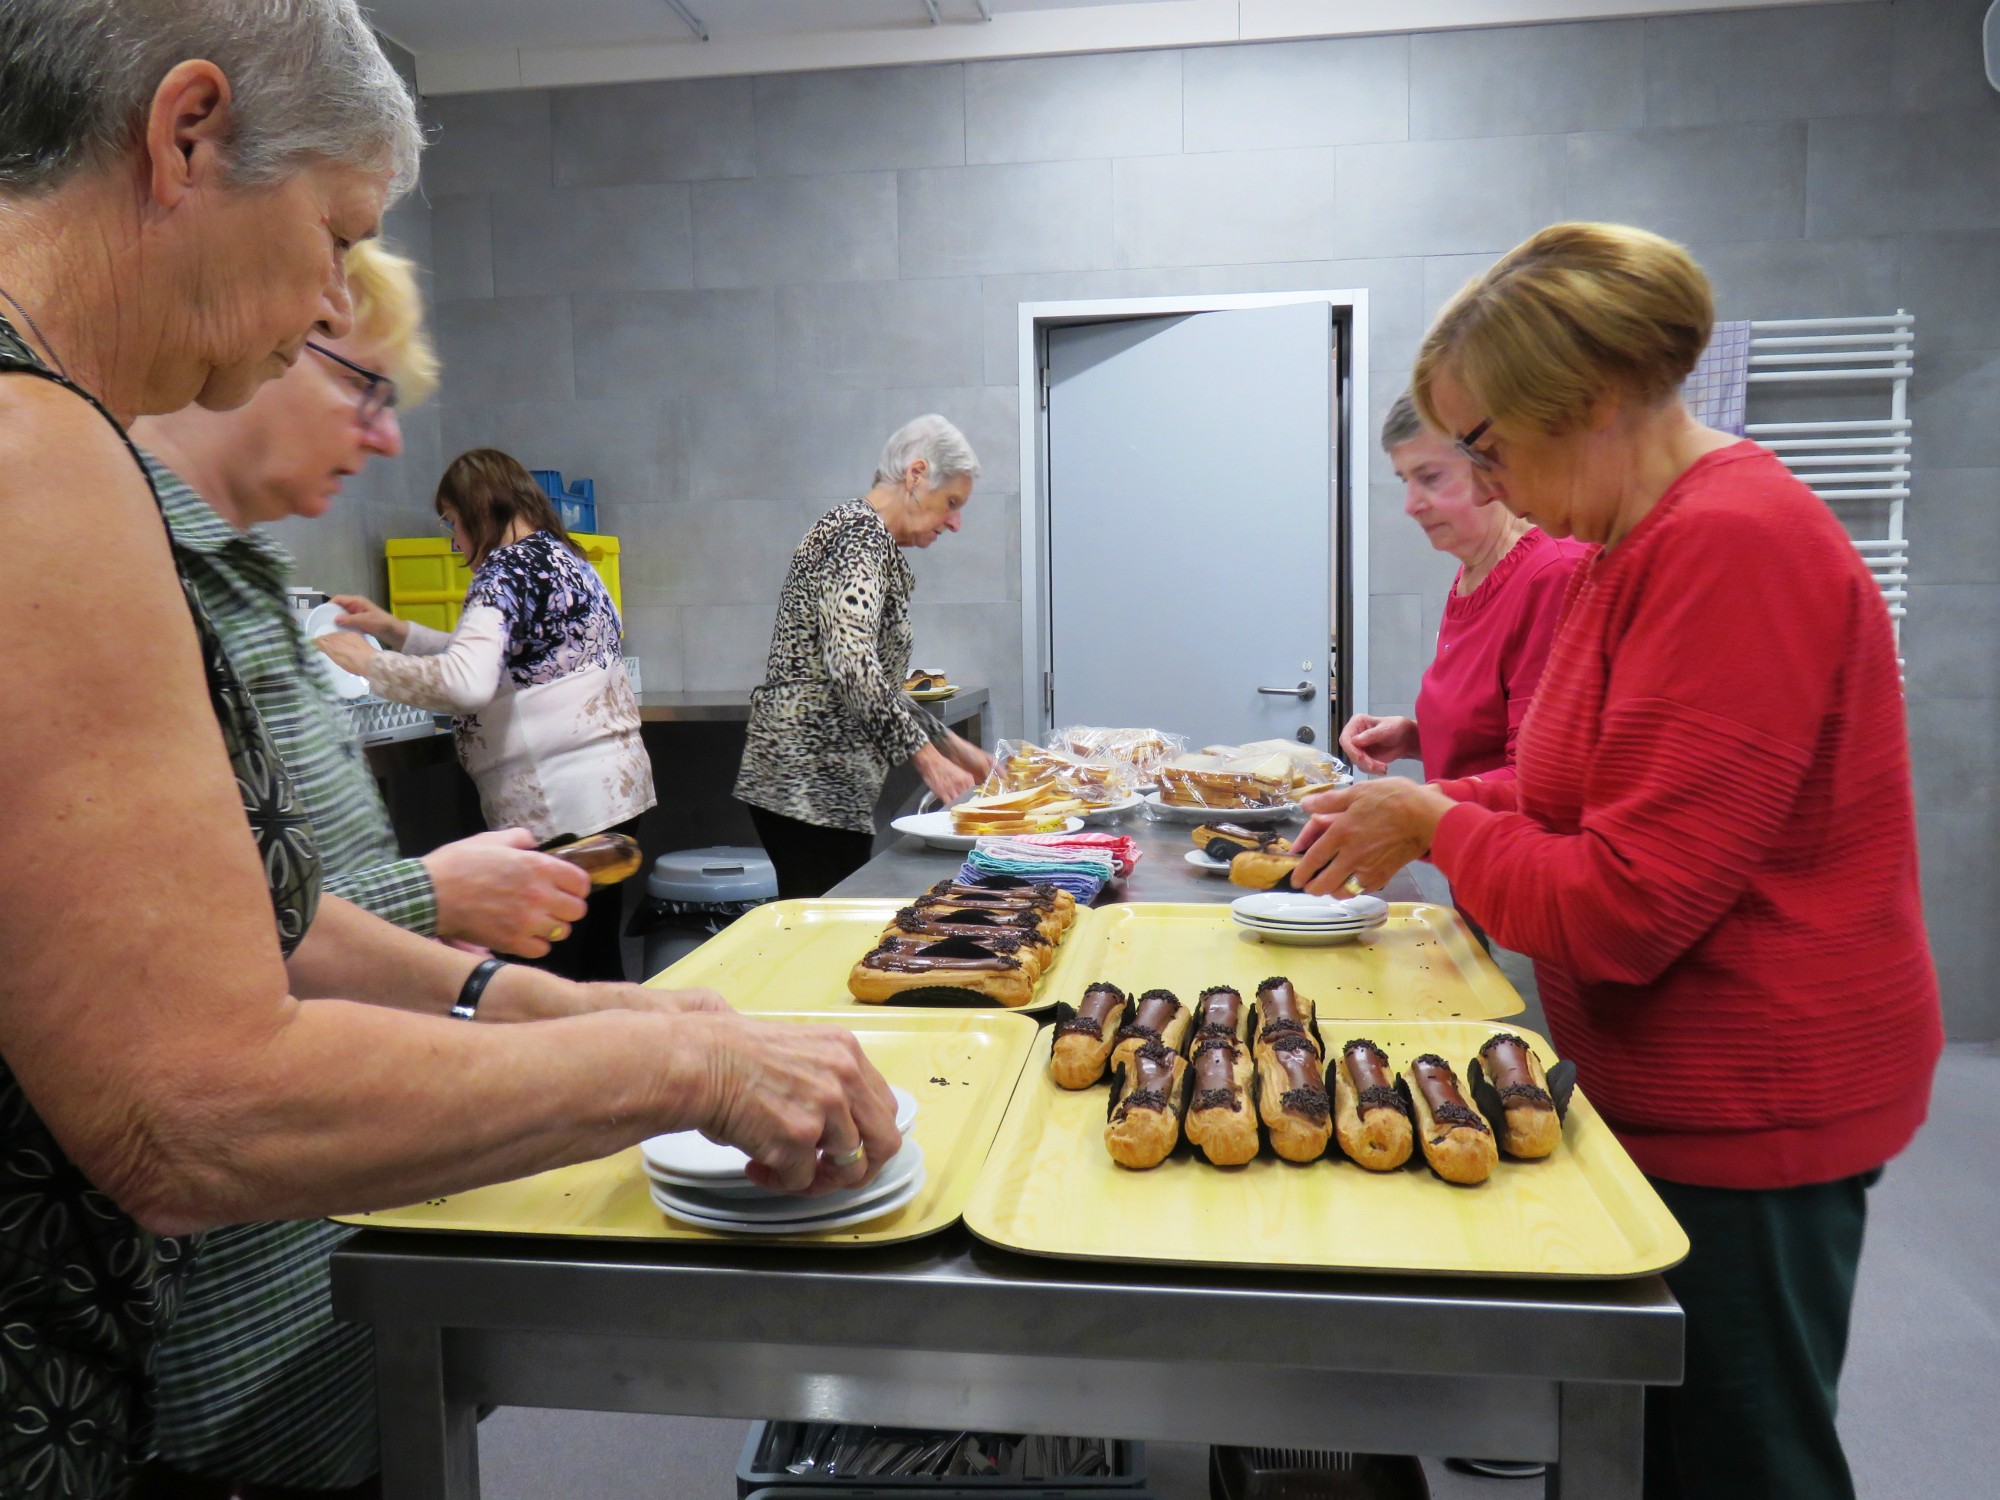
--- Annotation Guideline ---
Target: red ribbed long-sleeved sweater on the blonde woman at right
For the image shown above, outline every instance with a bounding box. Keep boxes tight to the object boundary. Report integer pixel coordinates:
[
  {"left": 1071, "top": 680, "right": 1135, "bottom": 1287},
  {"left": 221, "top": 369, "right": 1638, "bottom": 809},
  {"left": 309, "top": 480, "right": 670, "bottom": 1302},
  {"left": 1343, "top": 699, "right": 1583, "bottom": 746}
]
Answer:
[{"left": 1432, "top": 442, "right": 1944, "bottom": 1188}]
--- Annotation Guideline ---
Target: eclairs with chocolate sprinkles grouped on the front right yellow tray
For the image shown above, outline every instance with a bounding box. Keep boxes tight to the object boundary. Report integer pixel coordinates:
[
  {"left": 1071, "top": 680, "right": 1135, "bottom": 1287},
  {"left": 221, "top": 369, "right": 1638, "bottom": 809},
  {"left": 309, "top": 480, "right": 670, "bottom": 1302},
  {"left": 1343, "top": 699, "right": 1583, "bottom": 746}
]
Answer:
[{"left": 1050, "top": 976, "right": 1568, "bottom": 1184}]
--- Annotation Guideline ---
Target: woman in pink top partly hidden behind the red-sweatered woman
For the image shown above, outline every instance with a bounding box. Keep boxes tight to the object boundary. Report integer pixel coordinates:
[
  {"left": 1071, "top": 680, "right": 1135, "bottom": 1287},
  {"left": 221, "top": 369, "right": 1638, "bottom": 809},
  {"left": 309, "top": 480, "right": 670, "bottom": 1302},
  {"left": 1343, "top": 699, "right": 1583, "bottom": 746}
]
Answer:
[{"left": 1340, "top": 392, "right": 1590, "bottom": 792}]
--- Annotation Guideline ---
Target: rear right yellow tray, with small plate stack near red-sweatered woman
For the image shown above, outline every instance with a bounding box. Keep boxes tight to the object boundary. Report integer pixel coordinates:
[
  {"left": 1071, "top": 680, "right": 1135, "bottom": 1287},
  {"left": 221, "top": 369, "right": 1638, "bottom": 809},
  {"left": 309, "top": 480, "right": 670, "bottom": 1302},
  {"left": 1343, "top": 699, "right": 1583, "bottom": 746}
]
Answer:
[{"left": 1072, "top": 902, "right": 1524, "bottom": 1020}]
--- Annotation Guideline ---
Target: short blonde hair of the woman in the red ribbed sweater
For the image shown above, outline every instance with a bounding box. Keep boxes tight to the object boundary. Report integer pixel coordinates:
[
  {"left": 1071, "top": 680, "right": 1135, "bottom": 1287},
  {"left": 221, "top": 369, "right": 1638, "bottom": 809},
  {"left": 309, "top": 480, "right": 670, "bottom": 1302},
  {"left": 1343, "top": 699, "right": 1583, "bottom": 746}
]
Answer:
[{"left": 1410, "top": 224, "right": 1716, "bottom": 434}]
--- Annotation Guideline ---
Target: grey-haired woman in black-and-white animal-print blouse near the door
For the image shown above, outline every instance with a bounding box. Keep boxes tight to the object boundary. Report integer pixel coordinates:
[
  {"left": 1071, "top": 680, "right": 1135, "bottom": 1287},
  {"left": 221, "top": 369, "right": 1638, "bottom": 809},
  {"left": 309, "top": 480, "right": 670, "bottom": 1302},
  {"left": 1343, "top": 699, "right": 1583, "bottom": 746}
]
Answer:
[{"left": 736, "top": 414, "right": 992, "bottom": 898}]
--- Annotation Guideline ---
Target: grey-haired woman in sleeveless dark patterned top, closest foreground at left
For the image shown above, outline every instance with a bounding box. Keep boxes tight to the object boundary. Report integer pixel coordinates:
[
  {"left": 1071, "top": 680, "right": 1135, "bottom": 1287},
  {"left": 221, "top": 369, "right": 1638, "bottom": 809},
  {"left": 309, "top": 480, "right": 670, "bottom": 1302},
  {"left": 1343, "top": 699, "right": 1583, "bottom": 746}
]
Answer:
[{"left": 0, "top": 0, "right": 900, "bottom": 1500}]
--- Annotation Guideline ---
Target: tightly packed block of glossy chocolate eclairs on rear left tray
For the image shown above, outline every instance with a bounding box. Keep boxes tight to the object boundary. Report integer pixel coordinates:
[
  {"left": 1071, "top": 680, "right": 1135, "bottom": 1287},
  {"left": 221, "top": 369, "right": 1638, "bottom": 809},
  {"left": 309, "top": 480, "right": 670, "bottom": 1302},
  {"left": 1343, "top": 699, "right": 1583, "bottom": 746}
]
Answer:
[{"left": 848, "top": 880, "right": 1076, "bottom": 1006}]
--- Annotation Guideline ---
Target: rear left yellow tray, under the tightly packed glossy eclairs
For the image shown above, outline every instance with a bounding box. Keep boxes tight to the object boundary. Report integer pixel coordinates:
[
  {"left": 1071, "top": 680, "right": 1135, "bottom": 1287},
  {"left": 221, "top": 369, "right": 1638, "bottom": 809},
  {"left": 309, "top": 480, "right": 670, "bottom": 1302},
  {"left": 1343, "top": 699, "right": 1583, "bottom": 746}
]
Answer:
[{"left": 646, "top": 896, "right": 1100, "bottom": 1016}]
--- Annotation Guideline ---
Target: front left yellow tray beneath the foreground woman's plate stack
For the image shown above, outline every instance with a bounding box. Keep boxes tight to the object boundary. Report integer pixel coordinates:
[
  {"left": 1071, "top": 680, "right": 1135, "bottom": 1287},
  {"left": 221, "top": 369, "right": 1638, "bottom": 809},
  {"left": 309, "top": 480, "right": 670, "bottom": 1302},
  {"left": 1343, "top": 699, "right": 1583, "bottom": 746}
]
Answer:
[{"left": 340, "top": 1010, "right": 1038, "bottom": 1248}]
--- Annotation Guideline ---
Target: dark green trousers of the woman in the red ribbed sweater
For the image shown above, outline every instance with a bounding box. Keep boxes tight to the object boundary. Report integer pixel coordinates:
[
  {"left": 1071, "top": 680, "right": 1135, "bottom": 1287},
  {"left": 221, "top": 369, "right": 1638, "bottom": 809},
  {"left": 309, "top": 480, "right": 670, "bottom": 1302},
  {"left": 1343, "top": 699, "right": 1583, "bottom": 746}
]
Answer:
[{"left": 1646, "top": 1168, "right": 1882, "bottom": 1500}]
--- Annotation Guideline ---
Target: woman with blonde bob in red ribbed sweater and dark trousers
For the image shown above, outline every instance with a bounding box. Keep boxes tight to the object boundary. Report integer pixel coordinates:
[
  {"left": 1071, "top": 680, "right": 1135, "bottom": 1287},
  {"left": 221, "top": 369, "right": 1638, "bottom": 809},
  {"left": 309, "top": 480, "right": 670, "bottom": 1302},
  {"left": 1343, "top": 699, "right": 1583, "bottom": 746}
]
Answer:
[{"left": 1300, "top": 224, "right": 1942, "bottom": 1500}]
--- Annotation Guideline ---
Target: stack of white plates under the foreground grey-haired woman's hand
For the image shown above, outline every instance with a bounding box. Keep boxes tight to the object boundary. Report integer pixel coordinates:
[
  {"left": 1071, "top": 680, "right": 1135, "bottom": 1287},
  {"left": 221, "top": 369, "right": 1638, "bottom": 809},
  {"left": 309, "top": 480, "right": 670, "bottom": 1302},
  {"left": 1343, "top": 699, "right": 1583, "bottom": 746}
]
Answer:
[{"left": 640, "top": 1088, "right": 924, "bottom": 1234}]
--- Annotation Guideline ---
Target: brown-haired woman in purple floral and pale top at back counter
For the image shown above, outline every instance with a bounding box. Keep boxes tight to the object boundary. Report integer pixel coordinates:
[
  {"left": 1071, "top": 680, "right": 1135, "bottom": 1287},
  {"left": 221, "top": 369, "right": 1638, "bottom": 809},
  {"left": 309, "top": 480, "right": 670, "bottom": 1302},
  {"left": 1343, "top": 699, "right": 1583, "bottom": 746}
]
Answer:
[{"left": 318, "top": 448, "right": 654, "bottom": 980}]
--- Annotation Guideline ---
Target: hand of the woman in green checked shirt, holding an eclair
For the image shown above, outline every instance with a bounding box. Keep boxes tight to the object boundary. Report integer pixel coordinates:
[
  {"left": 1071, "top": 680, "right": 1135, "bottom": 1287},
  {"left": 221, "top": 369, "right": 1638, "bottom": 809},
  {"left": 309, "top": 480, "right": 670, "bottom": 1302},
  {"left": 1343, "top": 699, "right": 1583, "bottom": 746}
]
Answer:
[{"left": 416, "top": 828, "right": 590, "bottom": 958}]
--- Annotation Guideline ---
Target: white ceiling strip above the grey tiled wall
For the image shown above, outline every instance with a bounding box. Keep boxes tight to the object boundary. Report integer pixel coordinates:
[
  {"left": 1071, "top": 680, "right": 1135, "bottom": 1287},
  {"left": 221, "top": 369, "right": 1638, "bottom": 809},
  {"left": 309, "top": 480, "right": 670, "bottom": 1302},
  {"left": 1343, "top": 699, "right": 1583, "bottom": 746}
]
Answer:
[{"left": 376, "top": 0, "right": 1872, "bottom": 94}]
